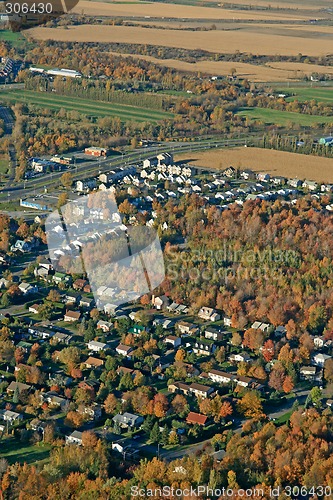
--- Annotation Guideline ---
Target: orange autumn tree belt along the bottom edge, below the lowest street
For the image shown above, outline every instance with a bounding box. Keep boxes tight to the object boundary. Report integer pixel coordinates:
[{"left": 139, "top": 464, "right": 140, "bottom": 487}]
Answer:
[{"left": 0, "top": 408, "right": 333, "bottom": 500}]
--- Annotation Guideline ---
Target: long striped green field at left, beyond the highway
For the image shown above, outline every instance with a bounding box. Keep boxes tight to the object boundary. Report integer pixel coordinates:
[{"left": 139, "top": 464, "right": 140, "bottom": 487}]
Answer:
[{"left": 0, "top": 90, "right": 174, "bottom": 122}]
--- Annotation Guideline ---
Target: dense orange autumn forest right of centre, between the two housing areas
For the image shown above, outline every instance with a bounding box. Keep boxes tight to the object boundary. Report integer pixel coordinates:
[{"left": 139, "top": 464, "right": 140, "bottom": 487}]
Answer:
[{"left": 154, "top": 196, "right": 333, "bottom": 334}]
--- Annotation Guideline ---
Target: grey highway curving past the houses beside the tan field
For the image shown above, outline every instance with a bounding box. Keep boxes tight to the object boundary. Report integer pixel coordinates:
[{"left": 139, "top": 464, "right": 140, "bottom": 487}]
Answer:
[{"left": 0, "top": 136, "right": 258, "bottom": 201}]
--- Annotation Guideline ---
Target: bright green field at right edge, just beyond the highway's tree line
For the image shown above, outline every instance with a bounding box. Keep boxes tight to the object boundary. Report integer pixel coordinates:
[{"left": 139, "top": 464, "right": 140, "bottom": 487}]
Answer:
[{"left": 238, "top": 108, "right": 333, "bottom": 127}]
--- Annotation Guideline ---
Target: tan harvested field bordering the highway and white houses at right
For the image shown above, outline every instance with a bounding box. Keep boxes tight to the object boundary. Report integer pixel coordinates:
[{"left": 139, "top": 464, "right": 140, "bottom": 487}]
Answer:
[{"left": 176, "top": 147, "right": 333, "bottom": 182}]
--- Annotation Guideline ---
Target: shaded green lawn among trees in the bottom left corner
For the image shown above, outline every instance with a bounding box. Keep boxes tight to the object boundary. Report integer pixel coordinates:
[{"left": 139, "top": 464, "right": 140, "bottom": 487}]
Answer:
[{"left": 0, "top": 437, "right": 51, "bottom": 464}]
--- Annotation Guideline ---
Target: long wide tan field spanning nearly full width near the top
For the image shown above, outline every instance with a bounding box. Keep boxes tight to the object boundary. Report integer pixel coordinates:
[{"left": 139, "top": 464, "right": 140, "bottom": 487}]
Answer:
[{"left": 29, "top": 25, "right": 333, "bottom": 56}]
